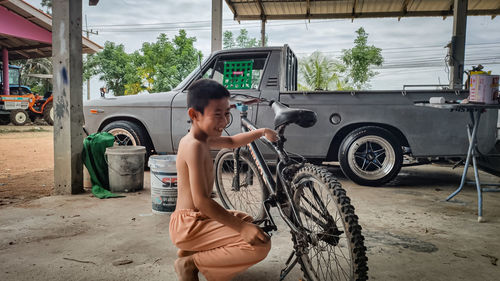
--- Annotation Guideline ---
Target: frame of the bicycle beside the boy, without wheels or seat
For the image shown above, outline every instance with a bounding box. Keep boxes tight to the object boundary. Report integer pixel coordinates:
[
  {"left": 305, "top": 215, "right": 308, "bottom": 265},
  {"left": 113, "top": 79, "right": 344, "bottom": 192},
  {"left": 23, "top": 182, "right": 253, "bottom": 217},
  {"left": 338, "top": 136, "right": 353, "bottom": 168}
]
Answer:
[{"left": 233, "top": 104, "right": 303, "bottom": 234}]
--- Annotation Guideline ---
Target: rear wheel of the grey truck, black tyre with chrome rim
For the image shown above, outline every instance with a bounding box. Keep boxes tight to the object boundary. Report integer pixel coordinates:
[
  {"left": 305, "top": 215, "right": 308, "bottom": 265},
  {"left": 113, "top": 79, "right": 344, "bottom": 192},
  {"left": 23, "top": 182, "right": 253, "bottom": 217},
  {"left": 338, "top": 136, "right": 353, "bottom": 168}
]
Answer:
[{"left": 339, "top": 126, "right": 403, "bottom": 186}]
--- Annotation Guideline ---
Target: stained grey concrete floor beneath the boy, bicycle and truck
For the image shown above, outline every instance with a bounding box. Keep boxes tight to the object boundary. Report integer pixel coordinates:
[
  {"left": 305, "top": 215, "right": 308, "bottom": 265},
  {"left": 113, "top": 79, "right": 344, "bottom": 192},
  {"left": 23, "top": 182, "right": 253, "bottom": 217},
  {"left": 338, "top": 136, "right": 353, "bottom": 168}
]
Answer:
[{"left": 0, "top": 165, "right": 500, "bottom": 281}]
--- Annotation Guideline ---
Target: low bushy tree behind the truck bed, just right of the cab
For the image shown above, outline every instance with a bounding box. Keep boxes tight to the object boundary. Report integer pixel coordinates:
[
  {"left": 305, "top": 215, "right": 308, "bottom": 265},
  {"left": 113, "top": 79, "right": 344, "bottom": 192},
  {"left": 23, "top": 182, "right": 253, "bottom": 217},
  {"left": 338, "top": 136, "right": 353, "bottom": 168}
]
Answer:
[{"left": 298, "top": 51, "right": 348, "bottom": 91}]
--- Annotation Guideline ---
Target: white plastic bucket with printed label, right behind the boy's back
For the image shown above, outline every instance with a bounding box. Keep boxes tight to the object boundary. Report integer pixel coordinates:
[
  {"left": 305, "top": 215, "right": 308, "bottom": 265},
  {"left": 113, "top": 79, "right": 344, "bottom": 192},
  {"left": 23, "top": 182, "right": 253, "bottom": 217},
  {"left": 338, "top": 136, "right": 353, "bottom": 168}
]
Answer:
[{"left": 148, "top": 155, "right": 177, "bottom": 214}]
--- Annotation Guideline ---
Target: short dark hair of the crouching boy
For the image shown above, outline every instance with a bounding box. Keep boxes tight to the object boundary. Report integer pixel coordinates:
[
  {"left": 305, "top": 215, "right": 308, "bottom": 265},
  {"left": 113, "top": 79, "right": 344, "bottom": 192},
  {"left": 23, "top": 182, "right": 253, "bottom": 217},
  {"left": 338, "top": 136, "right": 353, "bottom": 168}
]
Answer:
[{"left": 187, "top": 79, "right": 231, "bottom": 114}]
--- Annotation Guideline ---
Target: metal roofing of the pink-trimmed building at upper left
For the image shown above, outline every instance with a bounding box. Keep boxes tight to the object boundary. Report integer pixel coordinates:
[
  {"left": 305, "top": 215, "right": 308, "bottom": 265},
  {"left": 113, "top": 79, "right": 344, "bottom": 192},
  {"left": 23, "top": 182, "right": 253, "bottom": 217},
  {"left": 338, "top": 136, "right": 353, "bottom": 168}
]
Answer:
[{"left": 0, "top": 0, "right": 102, "bottom": 60}]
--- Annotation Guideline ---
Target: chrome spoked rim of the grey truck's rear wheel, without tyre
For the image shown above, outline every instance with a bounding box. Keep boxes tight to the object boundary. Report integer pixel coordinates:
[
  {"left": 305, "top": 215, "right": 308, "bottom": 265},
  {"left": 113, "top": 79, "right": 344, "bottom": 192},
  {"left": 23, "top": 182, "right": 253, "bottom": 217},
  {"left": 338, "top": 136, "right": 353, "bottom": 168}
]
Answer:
[{"left": 348, "top": 136, "right": 396, "bottom": 180}]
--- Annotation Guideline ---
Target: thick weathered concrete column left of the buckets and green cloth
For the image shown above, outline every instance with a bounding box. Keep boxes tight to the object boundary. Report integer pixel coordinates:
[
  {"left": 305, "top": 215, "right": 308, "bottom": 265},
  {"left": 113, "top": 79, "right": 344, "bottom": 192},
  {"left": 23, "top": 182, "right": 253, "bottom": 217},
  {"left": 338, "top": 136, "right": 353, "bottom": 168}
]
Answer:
[{"left": 52, "top": 0, "right": 83, "bottom": 194}]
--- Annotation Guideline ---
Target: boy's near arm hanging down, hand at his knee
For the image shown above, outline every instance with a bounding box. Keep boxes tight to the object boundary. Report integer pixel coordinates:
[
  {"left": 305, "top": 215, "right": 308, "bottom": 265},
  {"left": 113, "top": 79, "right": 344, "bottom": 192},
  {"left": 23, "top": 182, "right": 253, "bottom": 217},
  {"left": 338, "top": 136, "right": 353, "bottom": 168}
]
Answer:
[{"left": 185, "top": 143, "right": 269, "bottom": 244}]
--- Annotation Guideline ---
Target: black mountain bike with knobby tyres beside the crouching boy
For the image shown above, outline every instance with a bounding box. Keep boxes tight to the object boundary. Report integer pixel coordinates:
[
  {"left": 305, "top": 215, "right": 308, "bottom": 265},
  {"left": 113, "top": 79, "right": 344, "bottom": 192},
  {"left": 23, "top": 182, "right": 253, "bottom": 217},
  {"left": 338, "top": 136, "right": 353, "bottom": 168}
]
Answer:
[{"left": 214, "top": 95, "right": 368, "bottom": 281}]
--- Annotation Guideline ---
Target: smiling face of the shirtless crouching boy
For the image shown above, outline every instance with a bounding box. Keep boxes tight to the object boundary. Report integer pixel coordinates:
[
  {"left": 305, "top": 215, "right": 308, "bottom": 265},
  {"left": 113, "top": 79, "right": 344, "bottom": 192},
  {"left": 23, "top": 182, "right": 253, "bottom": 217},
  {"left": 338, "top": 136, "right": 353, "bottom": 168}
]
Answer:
[{"left": 191, "top": 98, "right": 230, "bottom": 137}]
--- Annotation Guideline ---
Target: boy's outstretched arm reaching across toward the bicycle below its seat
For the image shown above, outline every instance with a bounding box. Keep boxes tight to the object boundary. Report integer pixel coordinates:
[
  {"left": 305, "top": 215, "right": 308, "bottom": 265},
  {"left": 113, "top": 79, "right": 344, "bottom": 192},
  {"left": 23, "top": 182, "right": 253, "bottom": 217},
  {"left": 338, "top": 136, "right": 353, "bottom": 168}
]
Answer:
[{"left": 208, "top": 128, "right": 278, "bottom": 149}]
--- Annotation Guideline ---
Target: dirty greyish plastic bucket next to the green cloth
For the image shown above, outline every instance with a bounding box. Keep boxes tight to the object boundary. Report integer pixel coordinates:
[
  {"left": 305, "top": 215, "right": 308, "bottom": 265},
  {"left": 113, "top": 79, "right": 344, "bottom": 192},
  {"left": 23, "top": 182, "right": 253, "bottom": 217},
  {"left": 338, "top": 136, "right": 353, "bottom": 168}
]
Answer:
[{"left": 104, "top": 146, "right": 146, "bottom": 192}]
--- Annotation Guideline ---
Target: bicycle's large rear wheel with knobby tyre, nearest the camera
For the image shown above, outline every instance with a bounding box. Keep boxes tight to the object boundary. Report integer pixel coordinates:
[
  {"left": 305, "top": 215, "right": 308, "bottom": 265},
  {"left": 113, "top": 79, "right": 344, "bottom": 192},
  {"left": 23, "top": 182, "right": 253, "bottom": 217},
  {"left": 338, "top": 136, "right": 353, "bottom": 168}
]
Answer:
[{"left": 292, "top": 164, "right": 368, "bottom": 281}]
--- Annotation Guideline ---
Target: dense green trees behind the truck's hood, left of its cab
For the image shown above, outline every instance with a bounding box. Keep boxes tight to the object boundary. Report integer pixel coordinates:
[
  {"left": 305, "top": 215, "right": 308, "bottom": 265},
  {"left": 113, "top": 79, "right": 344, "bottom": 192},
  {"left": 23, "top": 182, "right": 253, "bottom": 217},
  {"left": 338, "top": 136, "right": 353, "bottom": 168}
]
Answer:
[{"left": 84, "top": 30, "right": 202, "bottom": 95}]
